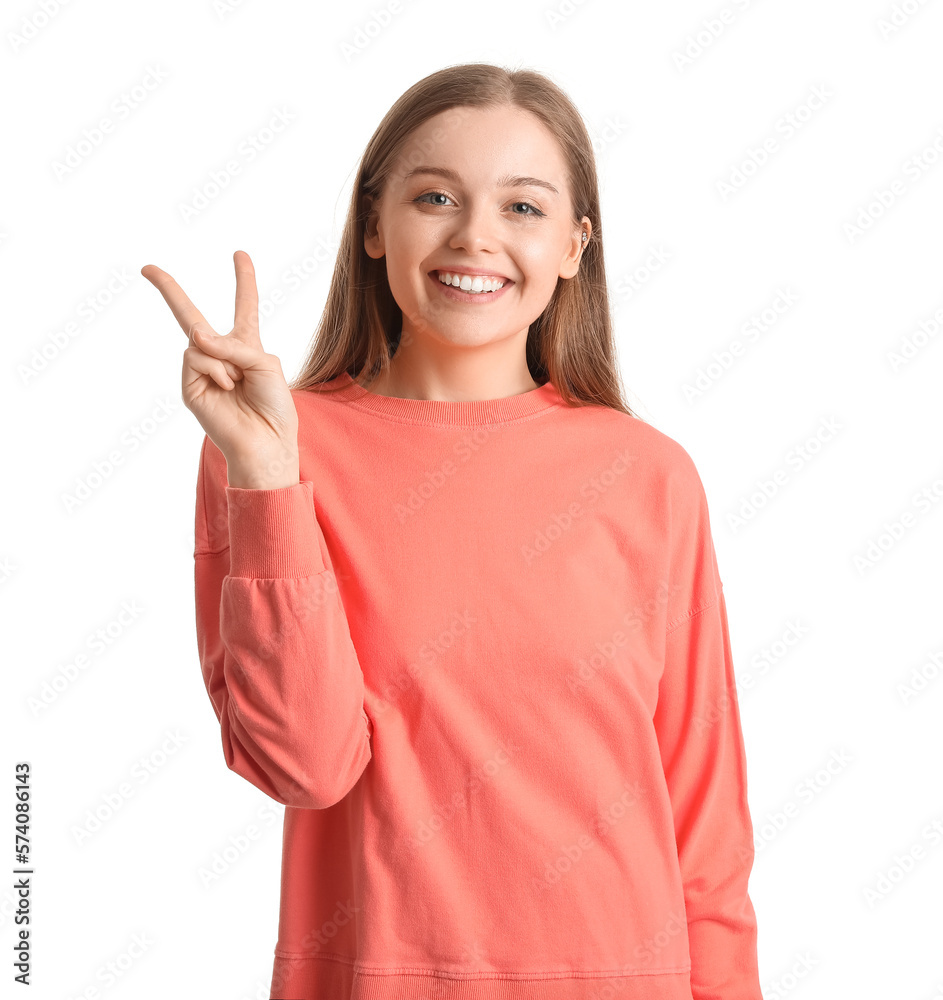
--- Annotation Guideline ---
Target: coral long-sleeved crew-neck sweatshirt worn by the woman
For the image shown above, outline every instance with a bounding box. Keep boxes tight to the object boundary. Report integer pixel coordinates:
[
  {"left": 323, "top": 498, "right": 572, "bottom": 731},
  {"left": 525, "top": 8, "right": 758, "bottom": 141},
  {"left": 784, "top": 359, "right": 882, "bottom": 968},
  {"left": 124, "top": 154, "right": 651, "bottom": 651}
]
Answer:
[{"left": 195, "top": 374, "right": 762, "bottom": 1000}]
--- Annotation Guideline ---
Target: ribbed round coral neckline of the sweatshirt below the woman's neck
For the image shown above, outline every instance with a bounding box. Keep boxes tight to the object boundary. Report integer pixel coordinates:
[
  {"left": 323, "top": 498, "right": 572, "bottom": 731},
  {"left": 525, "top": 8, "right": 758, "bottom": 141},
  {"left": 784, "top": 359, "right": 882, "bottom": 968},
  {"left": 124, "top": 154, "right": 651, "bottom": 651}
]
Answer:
[{"left": 331, "top": 371, "right": 564, "bottom": 427}]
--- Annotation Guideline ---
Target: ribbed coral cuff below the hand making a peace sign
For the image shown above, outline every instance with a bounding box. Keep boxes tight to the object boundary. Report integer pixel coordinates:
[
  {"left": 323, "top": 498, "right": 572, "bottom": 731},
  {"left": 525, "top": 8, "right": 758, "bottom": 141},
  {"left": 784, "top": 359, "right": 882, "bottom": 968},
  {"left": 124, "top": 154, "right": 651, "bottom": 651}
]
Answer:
[{"left": 226, "top": 481, "right": 326, "bottom": 579}]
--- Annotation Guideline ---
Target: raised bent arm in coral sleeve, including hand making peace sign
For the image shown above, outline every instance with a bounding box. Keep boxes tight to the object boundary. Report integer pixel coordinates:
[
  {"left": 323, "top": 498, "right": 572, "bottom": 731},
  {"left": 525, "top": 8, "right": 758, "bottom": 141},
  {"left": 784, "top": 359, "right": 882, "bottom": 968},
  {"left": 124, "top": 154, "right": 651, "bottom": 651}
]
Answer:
[{"left": 141, "top": 250, "right": 372, "bottom": 809}]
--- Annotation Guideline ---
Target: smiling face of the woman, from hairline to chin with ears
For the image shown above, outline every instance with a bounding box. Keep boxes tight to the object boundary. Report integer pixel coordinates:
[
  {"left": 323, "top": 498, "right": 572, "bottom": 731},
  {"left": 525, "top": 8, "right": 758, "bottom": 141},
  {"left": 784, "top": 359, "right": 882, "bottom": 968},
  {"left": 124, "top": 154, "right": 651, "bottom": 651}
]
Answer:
[{"left": 364, "top": 106, "right": 591, "bottom": 354}]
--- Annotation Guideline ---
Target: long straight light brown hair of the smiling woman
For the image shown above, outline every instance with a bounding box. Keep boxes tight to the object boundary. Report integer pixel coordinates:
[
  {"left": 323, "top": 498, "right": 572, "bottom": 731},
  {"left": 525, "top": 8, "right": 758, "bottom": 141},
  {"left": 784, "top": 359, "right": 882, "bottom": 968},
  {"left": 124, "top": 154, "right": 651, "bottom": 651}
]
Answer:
[{"left": 289, "top": 63, "right": 641, "bottom": 419}]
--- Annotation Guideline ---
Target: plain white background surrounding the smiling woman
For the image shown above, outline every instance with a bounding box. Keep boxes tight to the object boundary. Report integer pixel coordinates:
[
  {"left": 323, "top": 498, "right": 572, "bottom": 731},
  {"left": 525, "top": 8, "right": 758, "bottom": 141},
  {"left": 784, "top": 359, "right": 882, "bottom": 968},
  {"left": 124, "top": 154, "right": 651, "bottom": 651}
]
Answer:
[{"left": 0, "top": 0, "right": 943, "bottom": 1000}]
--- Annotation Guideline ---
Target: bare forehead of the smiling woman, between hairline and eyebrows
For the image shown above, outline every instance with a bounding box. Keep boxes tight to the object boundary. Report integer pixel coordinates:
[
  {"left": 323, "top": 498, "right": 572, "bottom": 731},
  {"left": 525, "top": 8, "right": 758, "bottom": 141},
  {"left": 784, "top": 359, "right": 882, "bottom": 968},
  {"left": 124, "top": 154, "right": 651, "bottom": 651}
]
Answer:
[{"left": 394, "top": 106, "right": 566, "bottom": 191}]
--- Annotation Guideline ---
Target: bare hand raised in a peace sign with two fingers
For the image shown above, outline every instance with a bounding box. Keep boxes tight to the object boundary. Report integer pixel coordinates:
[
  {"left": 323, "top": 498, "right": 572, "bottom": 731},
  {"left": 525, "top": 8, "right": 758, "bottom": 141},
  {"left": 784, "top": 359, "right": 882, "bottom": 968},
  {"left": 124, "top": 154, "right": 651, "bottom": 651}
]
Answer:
[{"left": 141, "top": 250, "right": 298, "bottom": 489}]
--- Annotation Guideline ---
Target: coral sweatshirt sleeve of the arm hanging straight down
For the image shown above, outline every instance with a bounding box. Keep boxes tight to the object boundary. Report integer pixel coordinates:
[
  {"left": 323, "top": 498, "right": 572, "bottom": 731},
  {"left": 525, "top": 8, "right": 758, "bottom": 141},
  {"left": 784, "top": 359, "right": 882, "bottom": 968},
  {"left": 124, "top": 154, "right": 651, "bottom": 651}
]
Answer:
[{"left": 654, "top": 452, "right": 762, "bottom": 1000}]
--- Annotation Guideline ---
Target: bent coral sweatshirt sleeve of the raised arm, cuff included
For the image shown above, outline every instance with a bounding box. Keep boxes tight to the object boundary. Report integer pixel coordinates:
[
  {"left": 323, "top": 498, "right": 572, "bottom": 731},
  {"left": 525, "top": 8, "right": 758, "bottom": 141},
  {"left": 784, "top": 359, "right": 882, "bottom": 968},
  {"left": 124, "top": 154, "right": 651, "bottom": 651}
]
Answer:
[{"left": 194, "top": 436, "right": 372, "bottom": 809}]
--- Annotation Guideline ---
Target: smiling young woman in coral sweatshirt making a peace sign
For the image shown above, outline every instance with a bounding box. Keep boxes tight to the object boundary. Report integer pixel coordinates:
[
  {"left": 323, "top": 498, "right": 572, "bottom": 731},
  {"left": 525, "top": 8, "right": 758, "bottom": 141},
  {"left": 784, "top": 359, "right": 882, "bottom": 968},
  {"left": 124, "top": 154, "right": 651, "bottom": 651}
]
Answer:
[{"left": 142, "top": 64, "right": 761, "bottom": 1000}]
